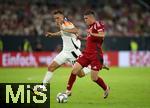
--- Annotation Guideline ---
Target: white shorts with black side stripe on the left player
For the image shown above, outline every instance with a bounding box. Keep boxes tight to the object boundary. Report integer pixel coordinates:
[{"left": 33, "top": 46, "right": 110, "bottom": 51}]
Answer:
[{"left": 54, "top": 49, "right": 81, "bottom": 65}]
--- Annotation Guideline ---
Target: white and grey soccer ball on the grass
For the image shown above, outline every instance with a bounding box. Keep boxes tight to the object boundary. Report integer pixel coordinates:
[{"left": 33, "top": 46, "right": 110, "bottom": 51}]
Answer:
[{"left": 56, "top": 93, "right": 68, "bottom": 103}]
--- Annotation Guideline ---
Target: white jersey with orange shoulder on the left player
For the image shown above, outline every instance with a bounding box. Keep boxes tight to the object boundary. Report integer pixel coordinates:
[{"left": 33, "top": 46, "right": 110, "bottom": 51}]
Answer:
[{"left": 61, "top": 21, "right": 81, "bottom": 51}]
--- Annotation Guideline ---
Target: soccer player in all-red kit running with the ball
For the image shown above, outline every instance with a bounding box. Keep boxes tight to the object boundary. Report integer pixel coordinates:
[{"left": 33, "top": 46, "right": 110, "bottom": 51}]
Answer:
[{"left": 67, "top": 10, "right": 110, "bottom": 98}]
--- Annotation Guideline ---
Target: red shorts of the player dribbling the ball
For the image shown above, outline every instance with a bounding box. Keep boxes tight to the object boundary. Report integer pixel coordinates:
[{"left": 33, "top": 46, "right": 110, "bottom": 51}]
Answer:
[{"left": 77, "top": 53, "right": 103, "bottom": 71}]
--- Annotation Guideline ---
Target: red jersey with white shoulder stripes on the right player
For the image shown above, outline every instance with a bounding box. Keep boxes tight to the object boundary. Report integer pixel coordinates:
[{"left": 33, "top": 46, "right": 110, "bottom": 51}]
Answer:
[{"left": 84, "top": 21, "right": 104, "bottom": 54}]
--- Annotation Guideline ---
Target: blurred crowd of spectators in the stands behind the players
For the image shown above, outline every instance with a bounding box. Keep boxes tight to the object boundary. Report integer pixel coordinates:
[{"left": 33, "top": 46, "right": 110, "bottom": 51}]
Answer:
[{"left": 0, "top": 0, "right": 150, "bottom": 36}]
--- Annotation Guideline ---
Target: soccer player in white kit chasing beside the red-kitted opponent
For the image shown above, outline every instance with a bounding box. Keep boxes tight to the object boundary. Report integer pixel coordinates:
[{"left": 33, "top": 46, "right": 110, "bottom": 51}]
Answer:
[{"left": 40, "top": 10, "right": 91, "bottom": 95}]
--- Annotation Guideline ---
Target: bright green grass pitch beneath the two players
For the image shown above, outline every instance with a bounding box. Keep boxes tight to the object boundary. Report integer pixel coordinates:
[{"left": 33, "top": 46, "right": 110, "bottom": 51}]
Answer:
[{"left": 0, "top": 67, "right": 150, "bottom": 108}]
